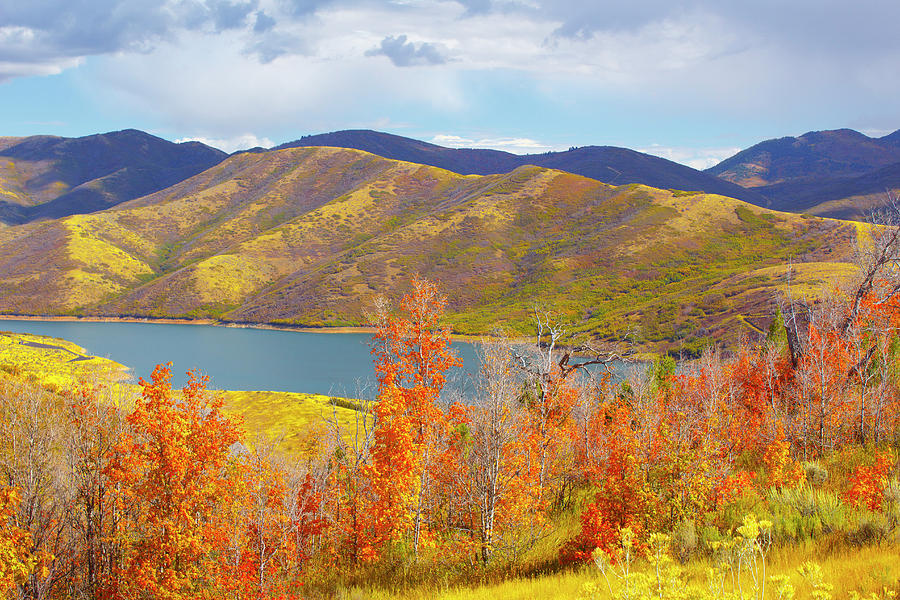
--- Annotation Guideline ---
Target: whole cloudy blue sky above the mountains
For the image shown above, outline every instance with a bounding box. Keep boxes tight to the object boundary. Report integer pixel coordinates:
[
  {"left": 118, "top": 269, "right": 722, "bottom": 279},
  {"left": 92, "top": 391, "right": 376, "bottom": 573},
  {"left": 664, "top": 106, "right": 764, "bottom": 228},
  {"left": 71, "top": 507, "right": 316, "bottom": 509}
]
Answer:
[{"left": 0, "top": 0, "right": 900, "bottom": 168}]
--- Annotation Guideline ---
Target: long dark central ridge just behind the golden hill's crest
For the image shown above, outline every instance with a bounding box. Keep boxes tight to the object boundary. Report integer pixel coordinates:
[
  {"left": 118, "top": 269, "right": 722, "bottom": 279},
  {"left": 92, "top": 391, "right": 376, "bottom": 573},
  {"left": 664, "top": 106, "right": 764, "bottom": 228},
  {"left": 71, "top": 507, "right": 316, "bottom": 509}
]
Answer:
[{"left": 275, "top": 130, "right": 765, "bottom": 204}]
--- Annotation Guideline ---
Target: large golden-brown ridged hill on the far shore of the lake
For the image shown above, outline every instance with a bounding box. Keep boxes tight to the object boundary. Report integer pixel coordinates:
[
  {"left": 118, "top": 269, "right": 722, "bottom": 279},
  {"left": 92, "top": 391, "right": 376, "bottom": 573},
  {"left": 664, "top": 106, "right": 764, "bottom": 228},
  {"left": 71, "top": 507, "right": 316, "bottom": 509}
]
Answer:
[{"left": 0, "top": 148, "right": 856, "bottom": 348}]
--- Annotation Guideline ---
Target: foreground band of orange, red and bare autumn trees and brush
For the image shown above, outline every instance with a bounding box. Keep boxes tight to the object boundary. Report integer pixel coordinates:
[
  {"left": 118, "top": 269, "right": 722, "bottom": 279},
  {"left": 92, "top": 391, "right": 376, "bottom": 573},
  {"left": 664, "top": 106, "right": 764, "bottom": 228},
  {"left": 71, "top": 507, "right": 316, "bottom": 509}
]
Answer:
[{"left": 0, "top": 220, "right": 900, "bottom": 600}]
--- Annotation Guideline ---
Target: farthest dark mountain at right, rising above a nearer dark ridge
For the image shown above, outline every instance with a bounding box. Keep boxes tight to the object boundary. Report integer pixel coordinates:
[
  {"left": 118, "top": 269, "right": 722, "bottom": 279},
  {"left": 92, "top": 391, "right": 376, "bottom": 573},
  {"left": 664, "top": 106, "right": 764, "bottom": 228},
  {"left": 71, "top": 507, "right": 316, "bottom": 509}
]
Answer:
[{"left": 706, "top": 129, "right": 900, "bottom": 188}]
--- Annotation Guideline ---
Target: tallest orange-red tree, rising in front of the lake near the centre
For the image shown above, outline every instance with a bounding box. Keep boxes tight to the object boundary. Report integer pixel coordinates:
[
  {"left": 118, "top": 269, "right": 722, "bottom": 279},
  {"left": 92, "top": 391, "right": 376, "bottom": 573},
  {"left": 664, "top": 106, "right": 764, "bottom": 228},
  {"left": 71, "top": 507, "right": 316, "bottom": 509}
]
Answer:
[{"left": 363, "top": 279, "right": 461, "bottom": 558}]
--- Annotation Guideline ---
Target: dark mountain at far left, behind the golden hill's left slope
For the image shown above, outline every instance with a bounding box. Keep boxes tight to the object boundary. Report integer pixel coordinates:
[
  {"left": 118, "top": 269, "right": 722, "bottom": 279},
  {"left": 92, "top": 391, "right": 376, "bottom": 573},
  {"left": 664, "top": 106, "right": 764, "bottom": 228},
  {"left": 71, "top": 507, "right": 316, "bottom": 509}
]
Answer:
[{"left": 0, "top": 129, "right": 227, "bottom": 223}]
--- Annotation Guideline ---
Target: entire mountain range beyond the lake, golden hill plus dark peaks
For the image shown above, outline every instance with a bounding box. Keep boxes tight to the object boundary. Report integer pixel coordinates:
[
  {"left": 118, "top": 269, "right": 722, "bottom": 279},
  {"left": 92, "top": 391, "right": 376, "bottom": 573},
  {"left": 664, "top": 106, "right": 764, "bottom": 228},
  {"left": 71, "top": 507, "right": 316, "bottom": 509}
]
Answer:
[{"left": 0, "top": 130, "right": 888, "bottom": 351}]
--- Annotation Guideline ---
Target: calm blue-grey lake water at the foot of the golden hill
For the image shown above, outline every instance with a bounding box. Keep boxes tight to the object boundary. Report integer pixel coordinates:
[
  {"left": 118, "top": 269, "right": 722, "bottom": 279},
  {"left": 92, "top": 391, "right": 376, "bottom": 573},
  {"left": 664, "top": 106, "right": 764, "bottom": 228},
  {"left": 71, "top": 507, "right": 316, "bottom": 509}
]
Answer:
[{"left": 0, "top": 321, "right": 486, "bottom": 397}]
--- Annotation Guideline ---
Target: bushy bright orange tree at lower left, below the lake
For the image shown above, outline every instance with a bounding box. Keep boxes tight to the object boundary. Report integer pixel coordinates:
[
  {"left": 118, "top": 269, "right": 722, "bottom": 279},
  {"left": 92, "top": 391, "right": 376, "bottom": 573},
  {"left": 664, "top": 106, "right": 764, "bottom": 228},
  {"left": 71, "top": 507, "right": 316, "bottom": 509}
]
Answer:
[{"left": 110, "top": 365, "right": 238, "bottom": 600}]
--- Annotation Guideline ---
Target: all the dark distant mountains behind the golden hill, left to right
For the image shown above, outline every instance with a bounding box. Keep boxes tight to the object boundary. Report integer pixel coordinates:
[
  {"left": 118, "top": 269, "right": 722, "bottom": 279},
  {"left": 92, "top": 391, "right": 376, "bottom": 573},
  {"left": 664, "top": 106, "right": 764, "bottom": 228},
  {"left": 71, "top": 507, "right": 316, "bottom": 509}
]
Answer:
[{"left": 0, "top": 129, "right": 900, "bottom": 224}]
